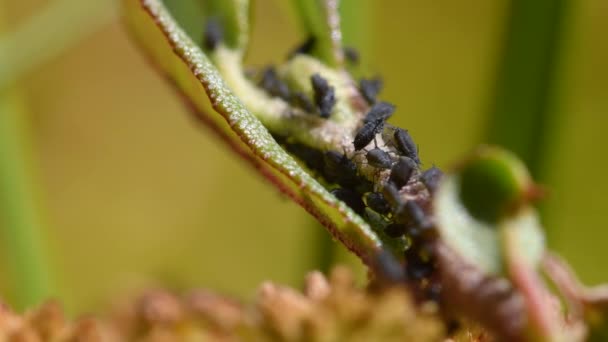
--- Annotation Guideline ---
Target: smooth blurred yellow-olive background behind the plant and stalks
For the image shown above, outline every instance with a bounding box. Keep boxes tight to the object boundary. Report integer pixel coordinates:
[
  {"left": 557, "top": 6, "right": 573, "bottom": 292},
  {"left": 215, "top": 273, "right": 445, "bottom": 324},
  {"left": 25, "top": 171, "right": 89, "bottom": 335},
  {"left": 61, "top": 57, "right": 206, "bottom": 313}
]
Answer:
[{"left": 0, "top": 0, "right": 608, "bottom": 312}]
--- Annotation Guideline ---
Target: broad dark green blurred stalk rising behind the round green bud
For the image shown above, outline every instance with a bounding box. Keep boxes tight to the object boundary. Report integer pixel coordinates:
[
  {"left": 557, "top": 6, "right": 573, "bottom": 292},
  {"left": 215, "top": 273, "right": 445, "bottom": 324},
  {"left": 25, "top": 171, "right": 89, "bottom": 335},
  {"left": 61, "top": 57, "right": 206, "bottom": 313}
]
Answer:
[{"left": 485, "top": 0, "right": 569, "bottom": 176}]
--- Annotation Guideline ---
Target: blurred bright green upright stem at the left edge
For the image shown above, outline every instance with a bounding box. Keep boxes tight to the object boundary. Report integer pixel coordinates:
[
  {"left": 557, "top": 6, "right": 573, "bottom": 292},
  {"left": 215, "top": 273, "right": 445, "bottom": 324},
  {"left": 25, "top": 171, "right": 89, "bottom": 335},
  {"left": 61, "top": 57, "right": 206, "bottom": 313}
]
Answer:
[{"left": 0, "top": 90, "right": 51, "bottom": 309}]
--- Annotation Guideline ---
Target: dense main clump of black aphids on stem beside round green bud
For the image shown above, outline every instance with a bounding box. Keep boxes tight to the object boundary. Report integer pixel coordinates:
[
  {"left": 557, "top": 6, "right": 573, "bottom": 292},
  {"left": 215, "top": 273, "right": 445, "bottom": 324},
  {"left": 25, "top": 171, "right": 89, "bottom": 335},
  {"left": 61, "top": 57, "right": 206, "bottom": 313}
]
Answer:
[{"left": 350, "top": 112, "right": 442, "bottom": 300}]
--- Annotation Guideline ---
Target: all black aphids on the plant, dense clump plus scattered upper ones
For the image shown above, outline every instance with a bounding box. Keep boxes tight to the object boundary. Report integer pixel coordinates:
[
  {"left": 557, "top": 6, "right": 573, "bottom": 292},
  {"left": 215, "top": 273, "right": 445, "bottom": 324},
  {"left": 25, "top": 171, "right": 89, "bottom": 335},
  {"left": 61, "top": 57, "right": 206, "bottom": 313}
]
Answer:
[{"left": 205, "top": 26, "right": 441, "bottom": 299}]
